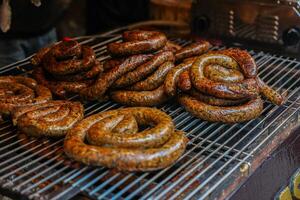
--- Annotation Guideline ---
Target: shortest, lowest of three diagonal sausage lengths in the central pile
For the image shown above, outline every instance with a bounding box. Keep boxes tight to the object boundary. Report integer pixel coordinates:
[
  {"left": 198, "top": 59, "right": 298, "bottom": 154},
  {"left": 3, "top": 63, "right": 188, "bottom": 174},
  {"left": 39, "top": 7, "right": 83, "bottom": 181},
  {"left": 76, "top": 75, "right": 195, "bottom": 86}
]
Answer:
[{"left": 128, "top": 61, "right": 174, "bottom": 91}]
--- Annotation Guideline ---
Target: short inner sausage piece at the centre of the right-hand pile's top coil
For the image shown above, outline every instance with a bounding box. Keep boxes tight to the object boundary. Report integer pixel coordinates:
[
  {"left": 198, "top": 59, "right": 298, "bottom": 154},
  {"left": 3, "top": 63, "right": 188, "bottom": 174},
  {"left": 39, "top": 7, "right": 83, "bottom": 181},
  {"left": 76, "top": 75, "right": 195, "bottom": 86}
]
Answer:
[{"left": 203, "top": 64, "right": 244, "bottom": 83}]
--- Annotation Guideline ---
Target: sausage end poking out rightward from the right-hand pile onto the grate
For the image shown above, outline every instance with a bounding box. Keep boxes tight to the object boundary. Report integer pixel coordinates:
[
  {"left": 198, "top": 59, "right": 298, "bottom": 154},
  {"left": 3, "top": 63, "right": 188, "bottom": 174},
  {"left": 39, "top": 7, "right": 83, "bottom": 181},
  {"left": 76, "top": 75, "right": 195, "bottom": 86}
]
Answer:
[{"left": 257, "top": 78, "right": 284, "bottom": 106}]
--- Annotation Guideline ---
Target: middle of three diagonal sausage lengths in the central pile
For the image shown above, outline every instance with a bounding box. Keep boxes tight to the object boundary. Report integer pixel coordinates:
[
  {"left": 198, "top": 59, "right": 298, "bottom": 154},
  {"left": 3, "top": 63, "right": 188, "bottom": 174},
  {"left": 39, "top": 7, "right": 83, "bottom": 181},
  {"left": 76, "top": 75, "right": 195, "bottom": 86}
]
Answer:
[{"left": 113, "top": 51, "right": 174, "bottom": 88}]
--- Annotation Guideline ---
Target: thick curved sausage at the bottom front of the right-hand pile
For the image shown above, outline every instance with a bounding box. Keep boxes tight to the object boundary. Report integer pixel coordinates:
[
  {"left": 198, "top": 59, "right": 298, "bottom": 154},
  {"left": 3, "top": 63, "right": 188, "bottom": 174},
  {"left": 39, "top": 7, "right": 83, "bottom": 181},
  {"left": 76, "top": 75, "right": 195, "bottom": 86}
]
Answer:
[{"left": 179, "top": 95, "right": 263, "bottom": 123}]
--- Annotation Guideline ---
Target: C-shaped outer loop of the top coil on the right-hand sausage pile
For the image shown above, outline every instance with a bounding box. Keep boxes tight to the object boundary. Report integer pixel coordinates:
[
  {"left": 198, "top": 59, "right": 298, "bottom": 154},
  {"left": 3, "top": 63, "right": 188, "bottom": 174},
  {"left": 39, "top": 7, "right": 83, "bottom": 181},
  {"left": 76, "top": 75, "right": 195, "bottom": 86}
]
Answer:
[{"left": 190, "top": 53, "right": 259, "bottom": 99}]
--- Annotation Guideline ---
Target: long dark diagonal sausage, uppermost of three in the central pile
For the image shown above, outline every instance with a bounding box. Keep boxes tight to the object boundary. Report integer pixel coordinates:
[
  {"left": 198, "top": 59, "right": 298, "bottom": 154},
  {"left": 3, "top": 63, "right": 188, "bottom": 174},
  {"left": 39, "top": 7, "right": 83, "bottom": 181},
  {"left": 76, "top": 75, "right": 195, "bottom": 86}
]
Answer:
[{"left": 80, "top": 54, "right": 151, "bottom": 100}]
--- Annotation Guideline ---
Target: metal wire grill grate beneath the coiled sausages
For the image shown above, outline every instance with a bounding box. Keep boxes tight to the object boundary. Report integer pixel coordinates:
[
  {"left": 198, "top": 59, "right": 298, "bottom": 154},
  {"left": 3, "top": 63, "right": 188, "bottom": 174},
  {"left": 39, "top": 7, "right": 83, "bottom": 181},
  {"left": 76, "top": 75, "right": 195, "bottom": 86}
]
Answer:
[{"left": 0, "top": 30, "right": 300, "bottom": 199}]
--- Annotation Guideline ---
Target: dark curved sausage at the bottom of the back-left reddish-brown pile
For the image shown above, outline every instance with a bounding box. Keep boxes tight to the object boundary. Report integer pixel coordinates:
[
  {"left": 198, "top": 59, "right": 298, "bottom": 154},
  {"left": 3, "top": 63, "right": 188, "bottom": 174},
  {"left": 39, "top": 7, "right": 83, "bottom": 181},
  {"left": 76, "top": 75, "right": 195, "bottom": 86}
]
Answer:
[{"left": 33, "top": 67, "right": 93, "bottom": 98}]
